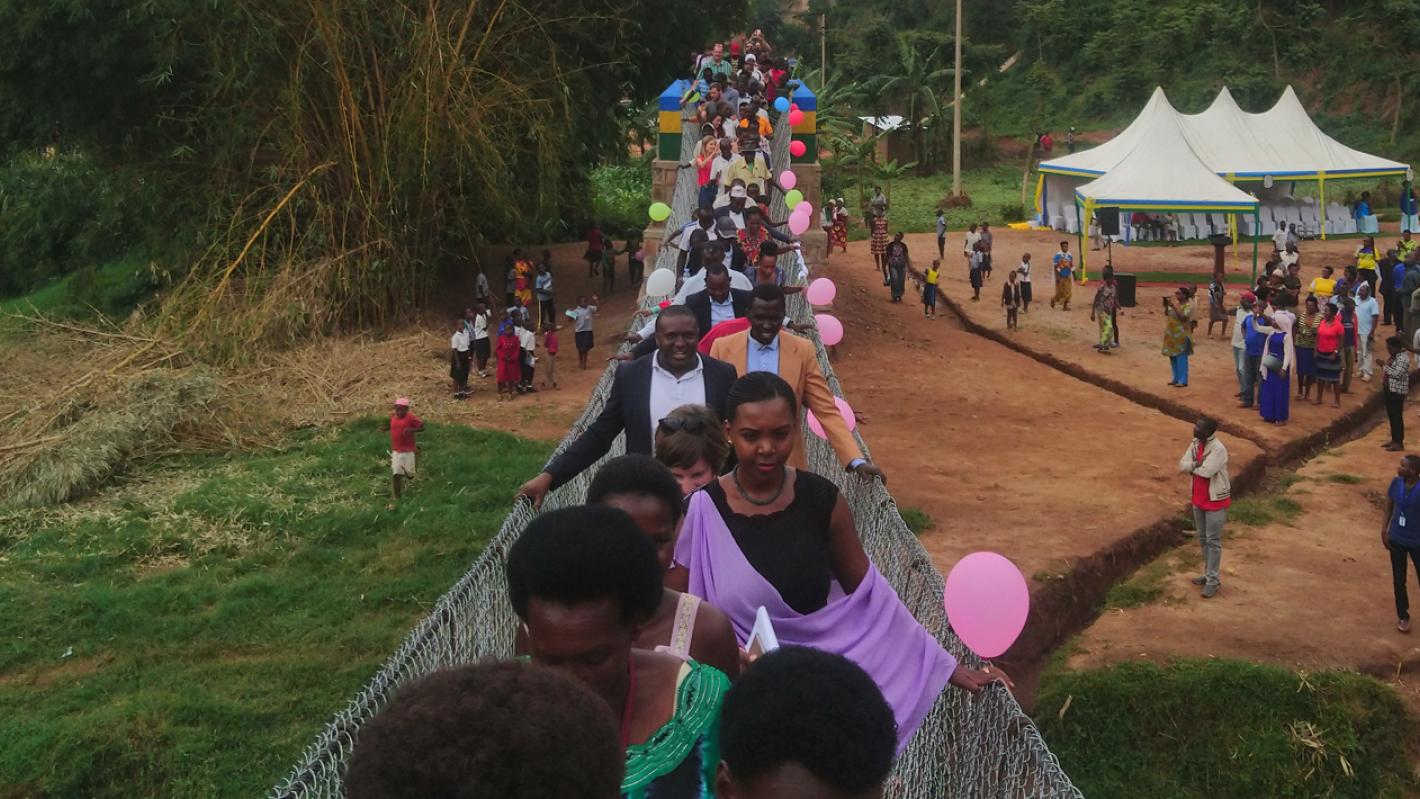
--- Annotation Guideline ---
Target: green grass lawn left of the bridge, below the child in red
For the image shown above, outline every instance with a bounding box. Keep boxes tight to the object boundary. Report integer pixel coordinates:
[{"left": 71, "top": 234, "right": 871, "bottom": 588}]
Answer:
[{"left": 0, "top": 419, "right": 550, "bottom": 798}]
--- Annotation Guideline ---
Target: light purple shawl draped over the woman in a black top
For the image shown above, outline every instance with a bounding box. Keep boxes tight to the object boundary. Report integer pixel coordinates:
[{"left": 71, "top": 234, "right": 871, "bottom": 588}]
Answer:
[{"left": 676, "top": 491, "right": 957, "bottom": 752}]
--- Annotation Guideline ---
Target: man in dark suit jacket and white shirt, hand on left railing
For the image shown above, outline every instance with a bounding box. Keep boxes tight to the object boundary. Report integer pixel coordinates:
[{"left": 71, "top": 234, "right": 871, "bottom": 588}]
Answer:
[{"left": 518, "top": 305, "right": 738, "bottom": 505}]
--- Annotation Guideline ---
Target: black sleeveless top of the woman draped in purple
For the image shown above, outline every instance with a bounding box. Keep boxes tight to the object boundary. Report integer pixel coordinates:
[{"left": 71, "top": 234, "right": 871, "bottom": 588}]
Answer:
[{"left": 706, "top": 470, "right": 838, "bottom": 616}]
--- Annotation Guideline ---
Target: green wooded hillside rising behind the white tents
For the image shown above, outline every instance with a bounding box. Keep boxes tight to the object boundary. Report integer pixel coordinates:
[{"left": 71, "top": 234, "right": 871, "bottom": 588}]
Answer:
[{"left": 751, "top": 0, "right": 1420, "bottom": 162}]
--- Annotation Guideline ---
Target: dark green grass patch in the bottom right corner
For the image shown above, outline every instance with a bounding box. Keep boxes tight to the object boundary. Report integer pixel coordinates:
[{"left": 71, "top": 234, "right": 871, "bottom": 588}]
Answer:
[{"left": 1035, "top": 660, "right": 1420, "bottom": 799}]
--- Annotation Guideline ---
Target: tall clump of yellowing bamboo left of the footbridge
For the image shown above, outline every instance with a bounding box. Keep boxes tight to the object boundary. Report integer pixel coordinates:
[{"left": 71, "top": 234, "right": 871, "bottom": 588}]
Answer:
[{"left": 160, "top": 0, "right": 615, "bottom": 362}]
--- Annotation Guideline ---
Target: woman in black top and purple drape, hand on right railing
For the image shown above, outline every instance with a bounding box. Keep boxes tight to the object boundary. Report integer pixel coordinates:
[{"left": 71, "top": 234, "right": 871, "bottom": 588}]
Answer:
[{"left": 666, "top": 372, "right": 1010, "bottom": 749}]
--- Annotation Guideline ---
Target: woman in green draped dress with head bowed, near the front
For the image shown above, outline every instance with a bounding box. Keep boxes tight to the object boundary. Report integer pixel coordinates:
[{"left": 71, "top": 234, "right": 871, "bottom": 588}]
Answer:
[{"left": 507, "top": 505, "right": 730, "bottom": 799}]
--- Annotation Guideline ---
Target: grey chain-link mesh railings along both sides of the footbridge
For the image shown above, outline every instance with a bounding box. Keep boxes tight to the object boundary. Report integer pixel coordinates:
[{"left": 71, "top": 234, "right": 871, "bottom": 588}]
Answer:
[{"left": 273, "top": 102, "right": 1079, "bottom": 799}]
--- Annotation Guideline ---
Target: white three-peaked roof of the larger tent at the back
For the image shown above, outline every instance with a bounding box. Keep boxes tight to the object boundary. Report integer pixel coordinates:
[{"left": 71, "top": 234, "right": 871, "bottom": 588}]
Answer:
[{"left": 1041, "top": 87, "right": 1407, "bottom": 180}]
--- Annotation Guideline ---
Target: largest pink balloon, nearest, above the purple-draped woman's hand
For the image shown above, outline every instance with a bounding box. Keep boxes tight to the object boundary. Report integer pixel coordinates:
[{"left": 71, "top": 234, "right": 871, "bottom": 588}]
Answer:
[{"left": 944, "top": 552, "right": 1031, "bottom": 659}]
